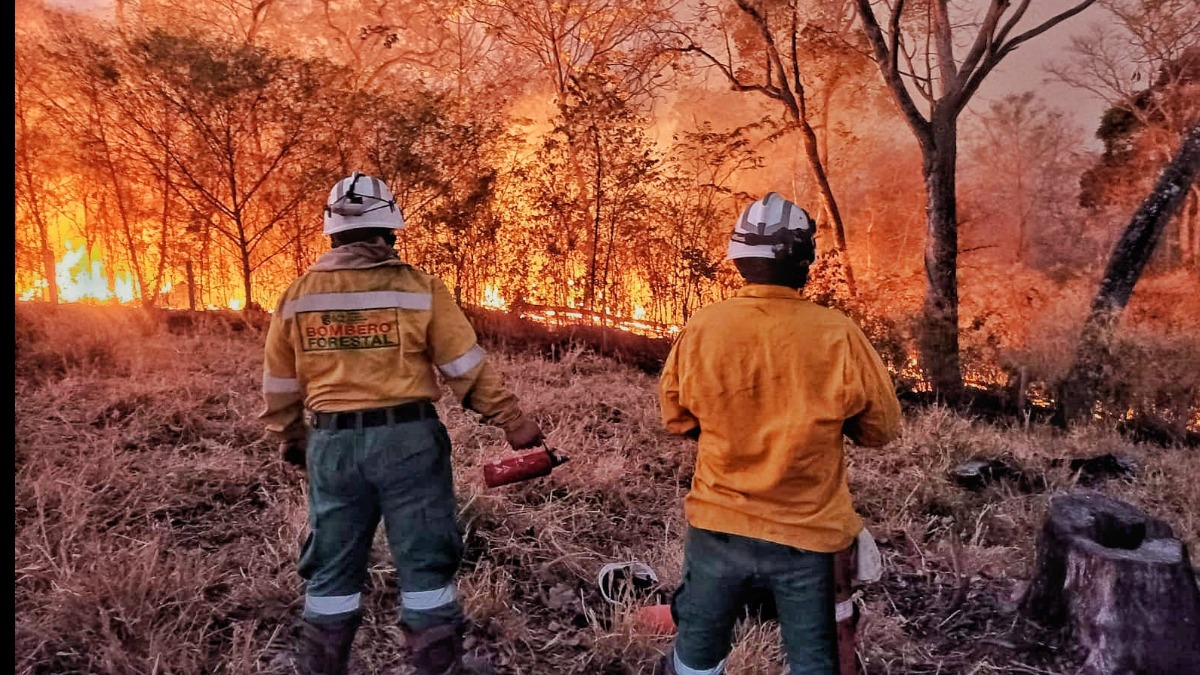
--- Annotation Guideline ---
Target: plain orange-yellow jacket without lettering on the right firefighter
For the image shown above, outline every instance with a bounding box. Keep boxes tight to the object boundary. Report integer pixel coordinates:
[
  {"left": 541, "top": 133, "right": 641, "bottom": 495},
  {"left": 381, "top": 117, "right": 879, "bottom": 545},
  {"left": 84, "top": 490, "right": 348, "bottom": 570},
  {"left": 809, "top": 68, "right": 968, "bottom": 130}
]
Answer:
[{"left": 659, "top": 285, "right": 900, "bottom": 552}]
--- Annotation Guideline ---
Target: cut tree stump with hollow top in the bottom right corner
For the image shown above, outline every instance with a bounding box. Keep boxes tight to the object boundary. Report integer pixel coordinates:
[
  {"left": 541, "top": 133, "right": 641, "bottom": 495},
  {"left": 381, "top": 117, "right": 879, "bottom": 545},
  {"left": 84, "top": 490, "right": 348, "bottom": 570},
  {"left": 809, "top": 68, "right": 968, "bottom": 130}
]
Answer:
[{"left": 1021, "top": 492, "right": 1200, "bottom": 675}]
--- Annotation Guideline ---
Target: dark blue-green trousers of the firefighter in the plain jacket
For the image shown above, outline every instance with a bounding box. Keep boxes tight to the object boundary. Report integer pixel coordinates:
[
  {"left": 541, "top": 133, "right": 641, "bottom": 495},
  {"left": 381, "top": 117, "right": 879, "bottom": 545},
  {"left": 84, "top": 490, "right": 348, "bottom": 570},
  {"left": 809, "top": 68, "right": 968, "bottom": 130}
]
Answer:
[{"left": 671, "top": 526, "right": 836, "bottom": 675}]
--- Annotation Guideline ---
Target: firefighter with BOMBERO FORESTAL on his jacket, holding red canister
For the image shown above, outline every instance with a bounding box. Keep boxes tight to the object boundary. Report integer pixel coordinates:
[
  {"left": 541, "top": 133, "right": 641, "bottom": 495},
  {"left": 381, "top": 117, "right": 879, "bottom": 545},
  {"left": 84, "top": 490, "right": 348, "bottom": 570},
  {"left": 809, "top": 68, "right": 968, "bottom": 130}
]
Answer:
[{"left": 260, "top": 173, "right": 542, "bottom": 675}]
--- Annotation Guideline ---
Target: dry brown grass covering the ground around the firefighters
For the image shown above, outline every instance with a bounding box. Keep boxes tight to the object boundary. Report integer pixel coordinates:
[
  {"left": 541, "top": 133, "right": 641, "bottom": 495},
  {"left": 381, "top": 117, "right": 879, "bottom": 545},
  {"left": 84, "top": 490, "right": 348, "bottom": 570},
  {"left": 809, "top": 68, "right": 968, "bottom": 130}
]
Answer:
[{"left": 14, "top": 304, "right": 1200, "bottom": 675}]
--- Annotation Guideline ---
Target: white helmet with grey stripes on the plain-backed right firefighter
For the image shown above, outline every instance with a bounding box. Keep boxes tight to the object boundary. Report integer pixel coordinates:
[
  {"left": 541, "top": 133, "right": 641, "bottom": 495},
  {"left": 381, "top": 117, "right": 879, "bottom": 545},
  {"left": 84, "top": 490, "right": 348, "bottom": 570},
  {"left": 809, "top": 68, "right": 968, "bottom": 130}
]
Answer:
[{"left": 725, "top": 192, "right": 816, "bottom": 261}]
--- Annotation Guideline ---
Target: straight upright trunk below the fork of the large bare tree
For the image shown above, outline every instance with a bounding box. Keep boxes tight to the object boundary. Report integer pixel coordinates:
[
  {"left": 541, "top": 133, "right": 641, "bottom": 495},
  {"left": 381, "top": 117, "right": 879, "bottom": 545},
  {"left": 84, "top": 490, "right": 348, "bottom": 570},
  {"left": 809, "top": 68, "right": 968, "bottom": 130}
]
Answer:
[{"left": 918, "top": 117, "right": 962, "bottom": 402}]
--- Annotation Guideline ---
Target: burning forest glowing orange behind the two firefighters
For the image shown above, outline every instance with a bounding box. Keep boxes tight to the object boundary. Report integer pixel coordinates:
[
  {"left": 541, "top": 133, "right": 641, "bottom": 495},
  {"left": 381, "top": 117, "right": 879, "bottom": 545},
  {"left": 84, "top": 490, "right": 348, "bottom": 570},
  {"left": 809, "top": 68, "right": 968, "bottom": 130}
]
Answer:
[{"left": 16, "top": 4, "right": 1200, "bottom": 408}]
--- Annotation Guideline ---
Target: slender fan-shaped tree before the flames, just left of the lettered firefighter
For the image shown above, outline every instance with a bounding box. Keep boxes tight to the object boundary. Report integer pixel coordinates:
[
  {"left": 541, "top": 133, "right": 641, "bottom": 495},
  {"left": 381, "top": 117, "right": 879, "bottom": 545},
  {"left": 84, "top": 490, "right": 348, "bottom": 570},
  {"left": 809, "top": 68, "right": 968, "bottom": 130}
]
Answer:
[{"left": 112, "top": 31, "right": 335, "bottom": 307}]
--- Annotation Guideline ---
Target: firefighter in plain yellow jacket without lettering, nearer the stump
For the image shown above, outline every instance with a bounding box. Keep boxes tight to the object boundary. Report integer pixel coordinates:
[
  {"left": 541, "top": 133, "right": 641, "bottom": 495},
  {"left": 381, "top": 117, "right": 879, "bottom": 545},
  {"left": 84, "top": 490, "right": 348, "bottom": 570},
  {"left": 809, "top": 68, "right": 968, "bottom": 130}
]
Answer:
[{"left": 659, "top": 192, "right": 900, "bottom": 675}]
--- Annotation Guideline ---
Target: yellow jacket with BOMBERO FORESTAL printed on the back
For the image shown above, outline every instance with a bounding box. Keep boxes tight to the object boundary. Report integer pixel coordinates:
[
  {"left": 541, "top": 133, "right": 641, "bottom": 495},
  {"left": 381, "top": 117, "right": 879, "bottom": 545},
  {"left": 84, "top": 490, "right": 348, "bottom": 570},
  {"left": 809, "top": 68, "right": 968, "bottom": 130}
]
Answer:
[{"left": 259, "top": 239, "right": 523, "bottom": 440}]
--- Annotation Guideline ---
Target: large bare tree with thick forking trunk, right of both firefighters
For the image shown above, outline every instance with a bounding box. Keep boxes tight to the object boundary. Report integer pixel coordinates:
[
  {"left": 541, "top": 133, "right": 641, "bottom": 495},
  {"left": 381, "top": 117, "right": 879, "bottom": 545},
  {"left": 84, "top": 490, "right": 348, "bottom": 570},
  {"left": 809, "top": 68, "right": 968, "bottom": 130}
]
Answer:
[{"left": 857, "top": 0, "right": 1096, "bottom": 400}]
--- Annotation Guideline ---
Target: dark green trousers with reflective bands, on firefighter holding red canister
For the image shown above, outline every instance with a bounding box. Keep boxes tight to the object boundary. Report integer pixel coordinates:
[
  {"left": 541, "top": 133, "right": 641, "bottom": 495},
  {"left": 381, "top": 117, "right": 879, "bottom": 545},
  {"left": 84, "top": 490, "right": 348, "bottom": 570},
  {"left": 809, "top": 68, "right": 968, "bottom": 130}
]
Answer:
[{"left": 299, "top": 418, "right": 463, "bottom": 629}]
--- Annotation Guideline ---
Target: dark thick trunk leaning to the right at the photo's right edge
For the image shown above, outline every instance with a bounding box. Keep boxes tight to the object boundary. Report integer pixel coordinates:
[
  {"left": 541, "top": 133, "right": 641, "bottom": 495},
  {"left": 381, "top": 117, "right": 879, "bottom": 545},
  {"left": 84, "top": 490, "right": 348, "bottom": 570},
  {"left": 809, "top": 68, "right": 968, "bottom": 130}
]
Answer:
[{"left": 1058, "top": 125, "right": 1200, "bottom": 423}]
